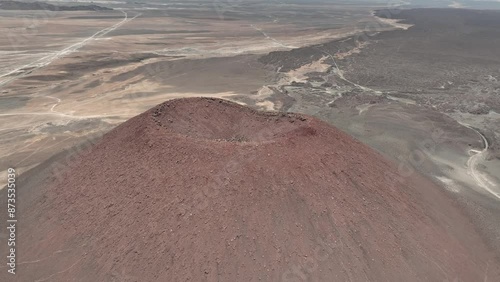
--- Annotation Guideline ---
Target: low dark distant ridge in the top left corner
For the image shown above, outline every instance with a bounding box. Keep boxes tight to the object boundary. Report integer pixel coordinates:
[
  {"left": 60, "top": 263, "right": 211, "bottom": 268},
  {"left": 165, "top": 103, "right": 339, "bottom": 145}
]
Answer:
[{"left": 0, "top": 1, "right": 113, "bottom": 11}]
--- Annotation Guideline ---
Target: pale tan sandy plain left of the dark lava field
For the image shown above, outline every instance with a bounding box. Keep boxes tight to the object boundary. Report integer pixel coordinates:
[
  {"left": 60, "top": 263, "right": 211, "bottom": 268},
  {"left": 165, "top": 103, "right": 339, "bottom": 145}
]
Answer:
[{"left": 0, "top": 3, "right": 391, "bottom": 186}]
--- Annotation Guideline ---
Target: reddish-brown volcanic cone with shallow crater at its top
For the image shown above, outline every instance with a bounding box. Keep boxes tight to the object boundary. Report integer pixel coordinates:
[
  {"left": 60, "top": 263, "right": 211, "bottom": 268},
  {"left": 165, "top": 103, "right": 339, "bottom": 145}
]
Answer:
[{"left": 4, "top": 98, "right": 500, "bottom": 282}]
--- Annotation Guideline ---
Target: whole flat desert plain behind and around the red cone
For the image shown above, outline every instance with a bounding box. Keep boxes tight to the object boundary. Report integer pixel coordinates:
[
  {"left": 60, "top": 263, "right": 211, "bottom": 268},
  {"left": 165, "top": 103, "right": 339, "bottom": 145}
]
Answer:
[{"left": 0, "top": 1, "right": 500, "bottom": 281}]
